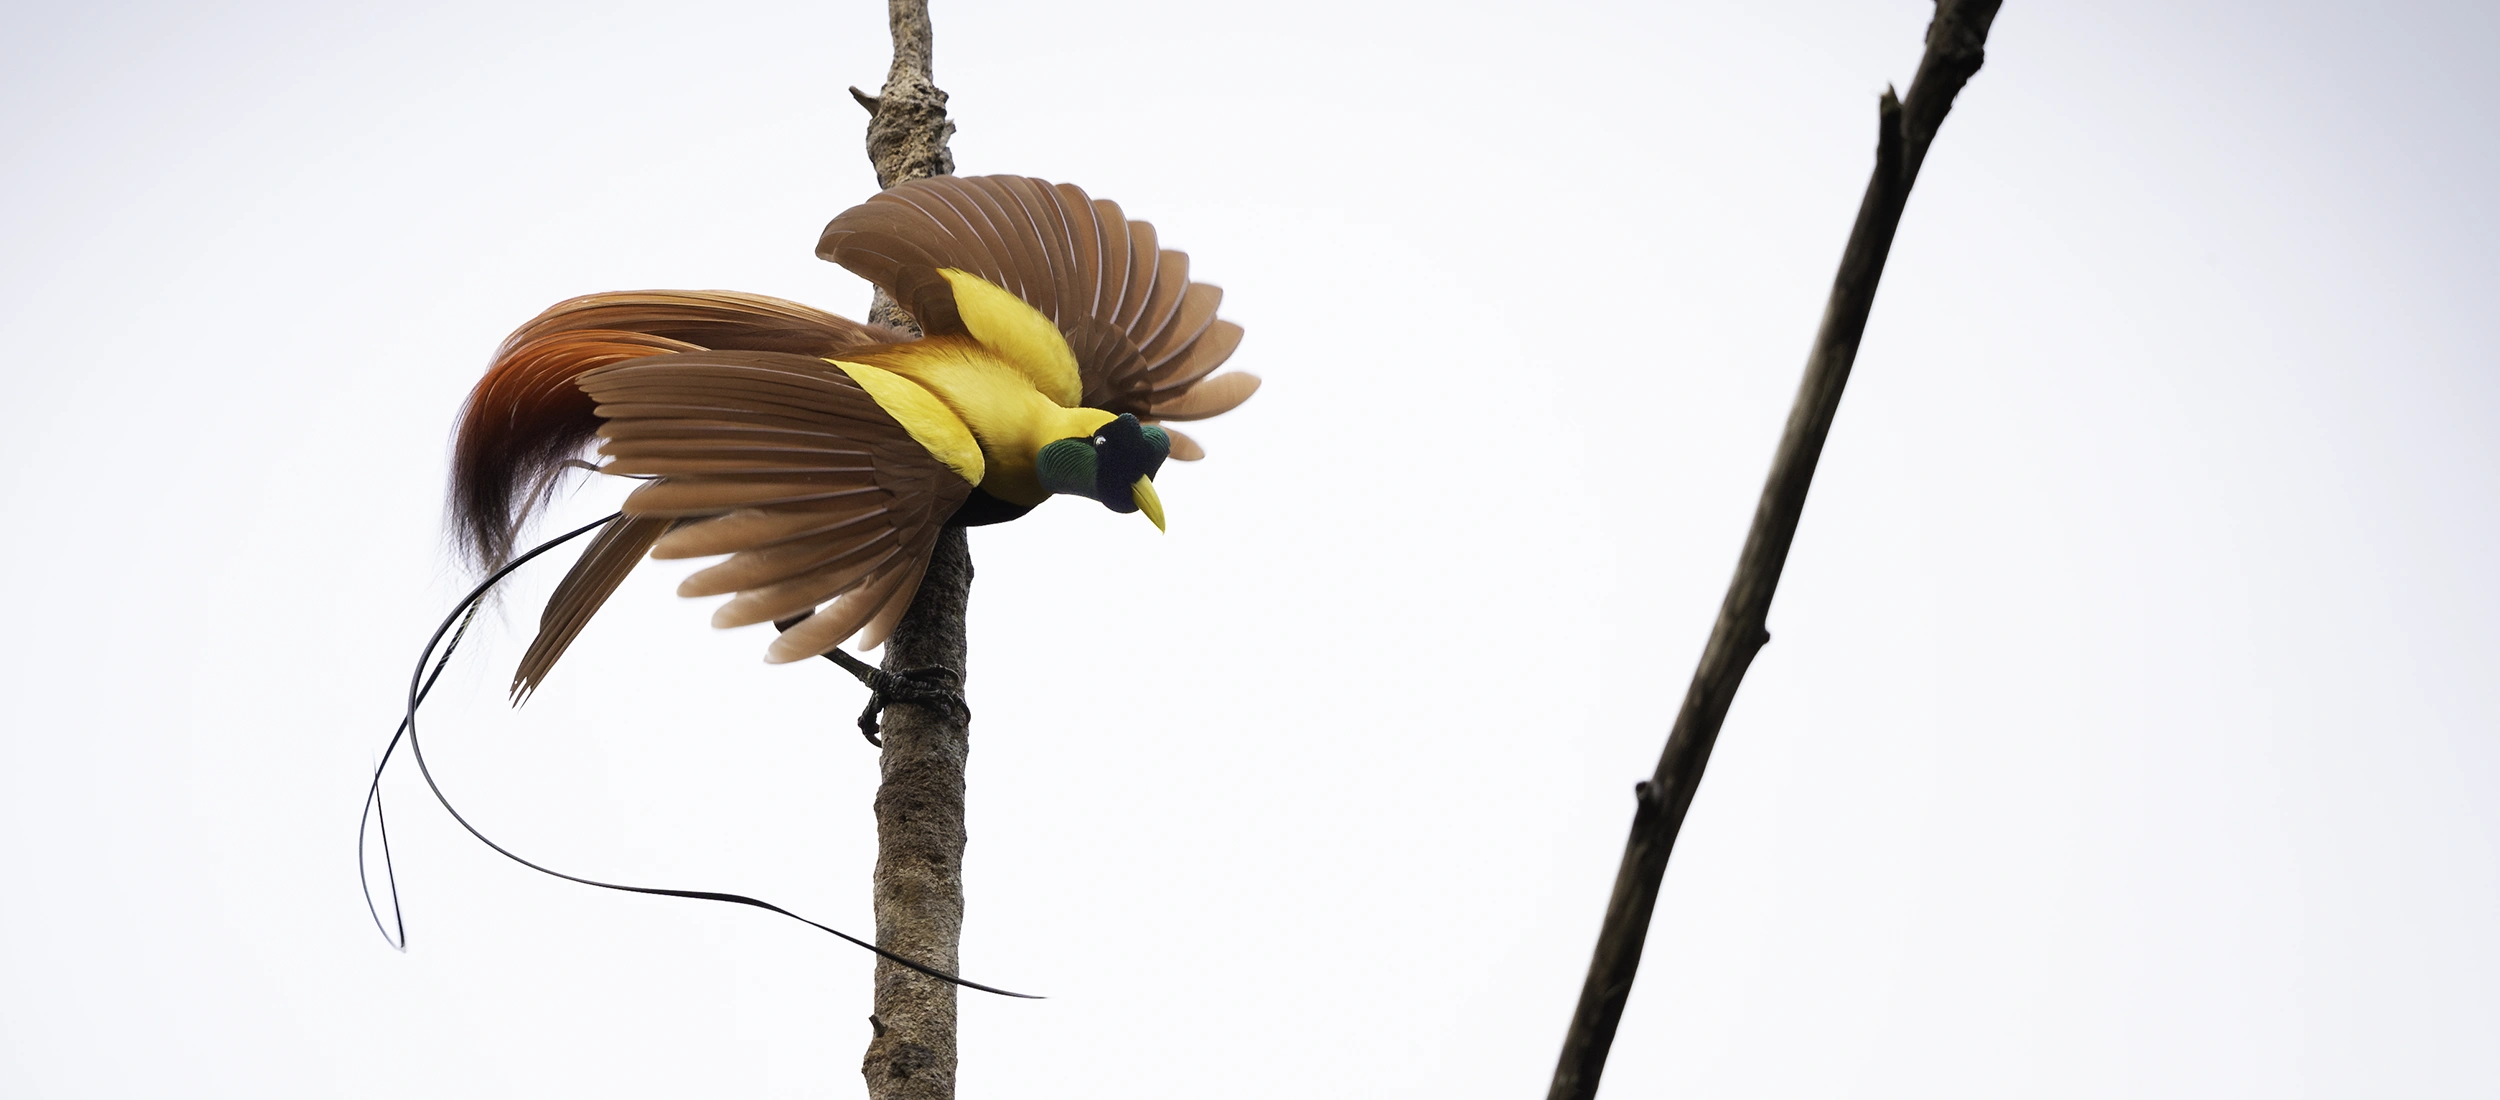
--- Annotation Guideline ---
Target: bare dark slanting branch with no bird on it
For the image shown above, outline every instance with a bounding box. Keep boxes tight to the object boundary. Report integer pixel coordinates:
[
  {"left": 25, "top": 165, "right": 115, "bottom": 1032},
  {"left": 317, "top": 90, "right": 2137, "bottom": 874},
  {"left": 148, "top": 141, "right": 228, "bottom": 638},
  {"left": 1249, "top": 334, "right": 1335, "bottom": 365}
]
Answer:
[{"left": 1548, "top": 0, "right": 2000, "bottom": 1100}]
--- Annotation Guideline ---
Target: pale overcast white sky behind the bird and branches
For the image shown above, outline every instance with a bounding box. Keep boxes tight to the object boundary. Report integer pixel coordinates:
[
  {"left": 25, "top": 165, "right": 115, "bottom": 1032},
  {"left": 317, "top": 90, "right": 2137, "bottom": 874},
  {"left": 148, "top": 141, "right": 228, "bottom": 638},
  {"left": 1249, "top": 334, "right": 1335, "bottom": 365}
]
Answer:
[{"left": 0, "top": 0, "right": 2500, "bottom": 1098}]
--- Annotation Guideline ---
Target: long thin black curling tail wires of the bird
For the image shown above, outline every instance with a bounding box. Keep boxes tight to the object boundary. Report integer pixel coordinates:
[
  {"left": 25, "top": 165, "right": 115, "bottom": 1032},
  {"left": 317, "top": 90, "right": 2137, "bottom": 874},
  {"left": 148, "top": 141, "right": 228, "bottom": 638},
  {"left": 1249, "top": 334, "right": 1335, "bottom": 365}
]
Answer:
[{"left": 355, "top": 513, "right": 1043, "bottom": 1000}]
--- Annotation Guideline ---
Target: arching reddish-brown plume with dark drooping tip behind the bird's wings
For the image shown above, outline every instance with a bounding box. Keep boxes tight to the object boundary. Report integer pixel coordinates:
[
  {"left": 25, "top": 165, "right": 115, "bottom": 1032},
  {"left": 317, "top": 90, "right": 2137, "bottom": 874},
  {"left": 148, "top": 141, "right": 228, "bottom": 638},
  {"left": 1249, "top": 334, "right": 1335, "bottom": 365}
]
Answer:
[{"left": 450, "top": 290, "right": 908, "bottom": 570}]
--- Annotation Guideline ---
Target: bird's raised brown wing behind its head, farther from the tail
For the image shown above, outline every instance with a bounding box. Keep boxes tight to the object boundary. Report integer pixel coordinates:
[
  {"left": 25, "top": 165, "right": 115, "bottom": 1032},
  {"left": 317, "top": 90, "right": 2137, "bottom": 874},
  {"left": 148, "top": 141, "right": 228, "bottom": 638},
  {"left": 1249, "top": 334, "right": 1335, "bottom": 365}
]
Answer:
[{"left": 815, "top": 175, "right": 1258, "bottom": 420}]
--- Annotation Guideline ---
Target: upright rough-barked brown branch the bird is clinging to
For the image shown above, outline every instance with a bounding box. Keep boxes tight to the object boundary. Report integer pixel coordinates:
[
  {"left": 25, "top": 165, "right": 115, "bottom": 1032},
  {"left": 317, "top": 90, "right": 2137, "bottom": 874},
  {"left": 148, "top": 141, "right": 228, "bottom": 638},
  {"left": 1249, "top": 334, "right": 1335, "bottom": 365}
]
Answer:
[{"left": 850, "top": 0, "right": 973, "bottom": 1100}]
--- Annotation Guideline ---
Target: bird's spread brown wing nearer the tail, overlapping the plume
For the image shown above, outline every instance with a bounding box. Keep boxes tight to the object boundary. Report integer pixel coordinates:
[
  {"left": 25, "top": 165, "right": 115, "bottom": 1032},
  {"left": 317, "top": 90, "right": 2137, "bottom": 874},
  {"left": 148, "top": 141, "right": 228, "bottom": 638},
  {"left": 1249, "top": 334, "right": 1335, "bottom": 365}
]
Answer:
[{"left": 580, "top": 353, "right": 978, "bottom": 663}]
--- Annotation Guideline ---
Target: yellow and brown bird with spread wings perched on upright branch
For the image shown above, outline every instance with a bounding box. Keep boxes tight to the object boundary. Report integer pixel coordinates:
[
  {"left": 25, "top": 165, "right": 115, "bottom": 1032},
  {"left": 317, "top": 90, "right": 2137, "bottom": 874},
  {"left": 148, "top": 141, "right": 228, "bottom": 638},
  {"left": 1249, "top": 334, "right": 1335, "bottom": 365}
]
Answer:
[{"left": 450, "top": 175, "right": 1258, "bottom": 695}]
